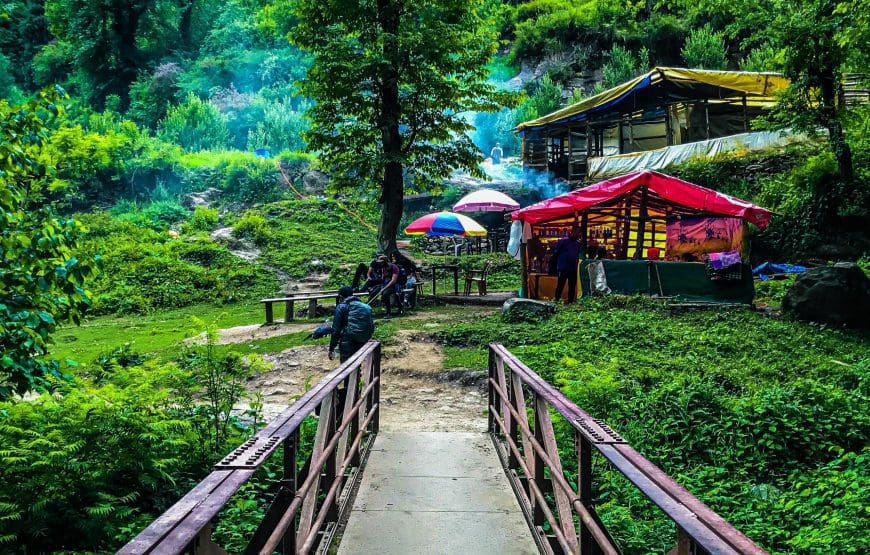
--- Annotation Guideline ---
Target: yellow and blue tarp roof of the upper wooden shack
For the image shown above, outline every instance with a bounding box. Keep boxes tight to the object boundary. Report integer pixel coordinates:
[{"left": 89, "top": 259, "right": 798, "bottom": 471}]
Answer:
[{"left": 515, "top": 67, "right": 791, "bottom": 131}]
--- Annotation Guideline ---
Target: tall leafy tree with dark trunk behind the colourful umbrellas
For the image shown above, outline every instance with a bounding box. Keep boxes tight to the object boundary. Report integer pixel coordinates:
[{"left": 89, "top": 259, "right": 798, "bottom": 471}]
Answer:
[{"left": 291, "top": 0, "right": 513, "bottom": 251}]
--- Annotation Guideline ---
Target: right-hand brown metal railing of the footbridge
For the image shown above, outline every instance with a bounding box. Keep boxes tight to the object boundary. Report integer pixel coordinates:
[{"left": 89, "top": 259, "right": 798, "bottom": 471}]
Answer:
[{"left": 488, "top": 343, "right": 765, "bottom": 555}]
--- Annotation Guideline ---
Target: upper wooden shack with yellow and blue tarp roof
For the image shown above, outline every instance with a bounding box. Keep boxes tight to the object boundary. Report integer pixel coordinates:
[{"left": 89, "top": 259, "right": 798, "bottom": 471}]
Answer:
[{"left": 516, "top": 67, "right": 789, "bottom": 185}]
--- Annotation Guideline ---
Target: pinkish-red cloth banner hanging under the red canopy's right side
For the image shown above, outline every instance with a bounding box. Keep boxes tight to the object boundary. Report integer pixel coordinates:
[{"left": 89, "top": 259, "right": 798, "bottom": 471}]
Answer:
[{"left": 665, "top": 218, "right": 743, "bottom": 261}]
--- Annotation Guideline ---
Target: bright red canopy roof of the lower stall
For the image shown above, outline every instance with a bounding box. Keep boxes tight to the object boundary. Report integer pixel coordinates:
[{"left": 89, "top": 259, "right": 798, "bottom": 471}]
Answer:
[{"left": 512, "top": 170, "right": 770, "bottom": 229}]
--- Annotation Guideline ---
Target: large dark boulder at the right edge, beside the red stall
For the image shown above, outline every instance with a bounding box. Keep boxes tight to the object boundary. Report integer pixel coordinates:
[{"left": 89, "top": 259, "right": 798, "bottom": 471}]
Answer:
[{"left": 782, "top": 262, "right": 870, "bottom": 328}]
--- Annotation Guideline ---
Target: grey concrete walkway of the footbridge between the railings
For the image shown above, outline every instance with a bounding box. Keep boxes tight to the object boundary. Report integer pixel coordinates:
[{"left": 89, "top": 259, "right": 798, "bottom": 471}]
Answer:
[{"left": 338, "top": 430, "right": 538, "bottom": 555}]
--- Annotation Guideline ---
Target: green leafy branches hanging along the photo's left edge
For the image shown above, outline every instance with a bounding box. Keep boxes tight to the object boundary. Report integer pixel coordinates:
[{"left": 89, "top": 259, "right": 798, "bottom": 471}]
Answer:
[{"left": 0, "top": 94, "right": 96, "bottom": 399}]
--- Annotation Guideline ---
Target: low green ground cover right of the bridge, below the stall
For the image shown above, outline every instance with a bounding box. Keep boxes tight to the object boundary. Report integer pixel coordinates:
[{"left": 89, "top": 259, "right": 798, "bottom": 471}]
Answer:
[{"left": 439, "top": 296, "right": 870, "bottom": 553}]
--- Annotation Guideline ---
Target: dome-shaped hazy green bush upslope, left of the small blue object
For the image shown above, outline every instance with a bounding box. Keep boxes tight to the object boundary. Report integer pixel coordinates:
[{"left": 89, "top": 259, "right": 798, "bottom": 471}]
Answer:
[{"left": 157, "top": 93, "right": 230, "bottom": 152}]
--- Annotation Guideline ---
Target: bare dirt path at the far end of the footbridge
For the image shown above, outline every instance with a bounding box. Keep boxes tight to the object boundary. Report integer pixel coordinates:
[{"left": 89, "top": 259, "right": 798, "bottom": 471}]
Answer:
[{"left": 247, "top": 326, "right": 486, "bottom": 432}]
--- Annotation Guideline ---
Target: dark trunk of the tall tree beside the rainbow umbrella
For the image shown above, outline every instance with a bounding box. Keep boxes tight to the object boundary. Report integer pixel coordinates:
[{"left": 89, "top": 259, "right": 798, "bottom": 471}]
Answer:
[{"left": 378, "top": 0, "right": 405, "bottom": 253}]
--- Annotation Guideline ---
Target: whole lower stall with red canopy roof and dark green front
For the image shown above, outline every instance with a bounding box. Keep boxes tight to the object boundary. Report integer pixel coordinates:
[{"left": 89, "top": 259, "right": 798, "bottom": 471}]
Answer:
[{"left": 512, "top": 170, "right": 771, "bottom": 301}]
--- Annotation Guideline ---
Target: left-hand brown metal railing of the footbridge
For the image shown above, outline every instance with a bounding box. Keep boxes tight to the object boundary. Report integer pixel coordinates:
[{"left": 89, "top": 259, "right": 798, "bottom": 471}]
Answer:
[{"left": 119, "top": 341, "right": 381, "bottom": 555}]
